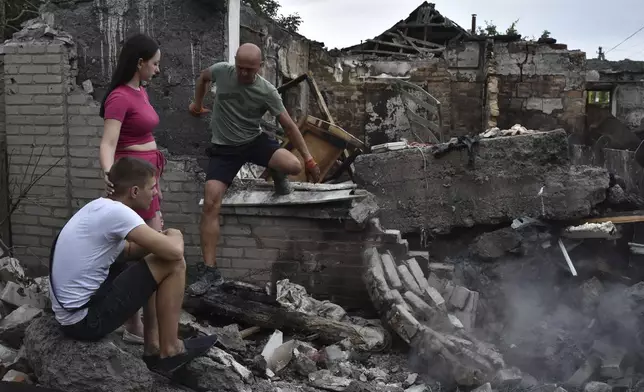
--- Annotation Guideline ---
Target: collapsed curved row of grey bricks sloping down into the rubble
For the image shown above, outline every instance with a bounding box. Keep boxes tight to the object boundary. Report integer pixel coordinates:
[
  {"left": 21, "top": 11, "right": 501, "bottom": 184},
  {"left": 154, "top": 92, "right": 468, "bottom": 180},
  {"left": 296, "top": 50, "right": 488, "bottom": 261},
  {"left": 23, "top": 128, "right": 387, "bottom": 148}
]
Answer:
[{"left": 364, "top": 248, "right": 505, "bottom": 387}]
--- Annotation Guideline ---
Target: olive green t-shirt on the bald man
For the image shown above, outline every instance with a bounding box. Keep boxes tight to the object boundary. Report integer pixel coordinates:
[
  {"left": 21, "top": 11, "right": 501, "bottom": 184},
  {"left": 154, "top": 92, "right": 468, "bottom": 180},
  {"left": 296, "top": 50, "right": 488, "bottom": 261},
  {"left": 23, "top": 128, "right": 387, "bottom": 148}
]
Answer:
[{"left": 210, "top": 62, "right": 286, "bottom": 146}]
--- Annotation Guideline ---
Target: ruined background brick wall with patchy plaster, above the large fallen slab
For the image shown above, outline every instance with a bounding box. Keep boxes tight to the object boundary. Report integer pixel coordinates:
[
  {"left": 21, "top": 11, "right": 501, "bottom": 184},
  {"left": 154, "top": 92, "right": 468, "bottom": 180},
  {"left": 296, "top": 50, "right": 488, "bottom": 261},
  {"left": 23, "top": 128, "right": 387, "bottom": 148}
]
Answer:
[{"left": 310, "top": 41, "right": 585, "bottom": 145}]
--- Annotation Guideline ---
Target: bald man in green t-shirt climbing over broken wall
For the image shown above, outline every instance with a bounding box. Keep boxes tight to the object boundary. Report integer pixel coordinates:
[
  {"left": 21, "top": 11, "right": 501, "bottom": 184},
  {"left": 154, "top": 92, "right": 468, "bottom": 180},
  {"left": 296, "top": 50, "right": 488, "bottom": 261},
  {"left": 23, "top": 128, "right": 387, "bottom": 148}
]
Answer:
[{"left": 188, "top": 44, "right": 320, "bottom": 295}]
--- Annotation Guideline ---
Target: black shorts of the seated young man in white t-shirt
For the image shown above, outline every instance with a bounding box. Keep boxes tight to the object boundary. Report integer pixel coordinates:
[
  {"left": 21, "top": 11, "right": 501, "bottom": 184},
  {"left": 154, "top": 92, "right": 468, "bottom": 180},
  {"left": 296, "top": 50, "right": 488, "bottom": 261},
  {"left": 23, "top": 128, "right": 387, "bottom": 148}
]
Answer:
[{"left": 62, "top": 260, "right": 158, "bottom": 341}]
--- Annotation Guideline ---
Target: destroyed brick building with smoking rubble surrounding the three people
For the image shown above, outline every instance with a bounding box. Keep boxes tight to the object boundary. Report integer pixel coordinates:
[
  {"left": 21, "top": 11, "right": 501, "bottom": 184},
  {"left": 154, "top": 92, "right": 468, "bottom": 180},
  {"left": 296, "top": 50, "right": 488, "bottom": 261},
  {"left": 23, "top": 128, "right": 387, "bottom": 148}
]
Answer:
[{"left": 0, "top": 0, "right": 644, "bottom": 392}]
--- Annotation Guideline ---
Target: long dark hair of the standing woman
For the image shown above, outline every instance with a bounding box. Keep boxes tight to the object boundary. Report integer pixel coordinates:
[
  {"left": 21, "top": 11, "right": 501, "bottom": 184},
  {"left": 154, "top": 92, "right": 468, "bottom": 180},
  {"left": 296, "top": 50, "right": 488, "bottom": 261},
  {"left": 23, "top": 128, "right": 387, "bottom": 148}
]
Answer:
[{"left": 100, "top": 34, "right": 159, "bottom": 117}]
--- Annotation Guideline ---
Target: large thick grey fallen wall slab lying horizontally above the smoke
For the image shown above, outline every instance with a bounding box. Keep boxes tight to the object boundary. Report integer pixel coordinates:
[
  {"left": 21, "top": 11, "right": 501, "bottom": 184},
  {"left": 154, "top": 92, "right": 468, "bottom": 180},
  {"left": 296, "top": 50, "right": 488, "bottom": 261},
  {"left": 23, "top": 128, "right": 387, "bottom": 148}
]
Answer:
[{"left": 355, "top": 130, "right": 610, "bottom": 233}]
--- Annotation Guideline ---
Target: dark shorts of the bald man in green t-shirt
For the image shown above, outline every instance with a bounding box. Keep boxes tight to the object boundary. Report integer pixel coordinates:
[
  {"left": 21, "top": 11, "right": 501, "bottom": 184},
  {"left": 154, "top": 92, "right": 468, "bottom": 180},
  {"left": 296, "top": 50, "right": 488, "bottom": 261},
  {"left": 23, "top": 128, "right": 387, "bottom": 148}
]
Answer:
[{"left": 206, "top": 132, "right": 280, "bottom": 185}]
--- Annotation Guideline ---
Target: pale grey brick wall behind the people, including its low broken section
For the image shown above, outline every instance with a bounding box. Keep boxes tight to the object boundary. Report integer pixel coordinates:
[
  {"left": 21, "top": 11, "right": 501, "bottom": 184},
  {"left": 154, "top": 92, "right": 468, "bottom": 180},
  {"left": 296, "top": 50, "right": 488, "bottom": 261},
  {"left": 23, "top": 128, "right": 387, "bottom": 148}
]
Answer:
[{"left": 3, "top": 37, "right": 384, "bottom": 306}]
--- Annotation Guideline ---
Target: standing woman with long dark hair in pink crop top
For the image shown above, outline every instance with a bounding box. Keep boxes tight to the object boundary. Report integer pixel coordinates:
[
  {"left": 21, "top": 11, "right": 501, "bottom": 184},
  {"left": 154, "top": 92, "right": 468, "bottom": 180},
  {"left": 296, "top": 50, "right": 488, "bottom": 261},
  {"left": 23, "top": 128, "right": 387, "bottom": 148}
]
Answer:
[{"left": 99, "top": 34, "right": 165, "bottom": 344}]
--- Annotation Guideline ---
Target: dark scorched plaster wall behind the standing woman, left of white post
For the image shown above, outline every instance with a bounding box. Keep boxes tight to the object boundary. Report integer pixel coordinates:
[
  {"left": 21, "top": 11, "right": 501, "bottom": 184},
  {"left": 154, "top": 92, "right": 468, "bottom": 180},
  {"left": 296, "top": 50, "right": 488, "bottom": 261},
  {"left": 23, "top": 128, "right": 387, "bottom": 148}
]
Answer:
[{"left": 50, "top": 0, "right": 227, "bottom": 155}]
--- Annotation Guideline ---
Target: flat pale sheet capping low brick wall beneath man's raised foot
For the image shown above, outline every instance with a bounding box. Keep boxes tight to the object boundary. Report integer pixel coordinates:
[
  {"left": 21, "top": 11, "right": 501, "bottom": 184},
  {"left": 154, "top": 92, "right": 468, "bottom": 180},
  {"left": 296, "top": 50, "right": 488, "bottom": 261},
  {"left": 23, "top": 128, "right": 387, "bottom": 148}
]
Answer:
[{"left": 211, "top": 189, "right": 364, "bottom": 207}]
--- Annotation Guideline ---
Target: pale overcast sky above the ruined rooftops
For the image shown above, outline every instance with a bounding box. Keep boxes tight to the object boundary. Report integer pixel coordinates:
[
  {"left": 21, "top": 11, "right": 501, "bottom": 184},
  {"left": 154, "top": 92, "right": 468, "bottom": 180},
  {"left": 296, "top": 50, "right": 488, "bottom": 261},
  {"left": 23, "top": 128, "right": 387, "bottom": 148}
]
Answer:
[{"left": 279, "top": 0, "right": 644, "bottom": 60}]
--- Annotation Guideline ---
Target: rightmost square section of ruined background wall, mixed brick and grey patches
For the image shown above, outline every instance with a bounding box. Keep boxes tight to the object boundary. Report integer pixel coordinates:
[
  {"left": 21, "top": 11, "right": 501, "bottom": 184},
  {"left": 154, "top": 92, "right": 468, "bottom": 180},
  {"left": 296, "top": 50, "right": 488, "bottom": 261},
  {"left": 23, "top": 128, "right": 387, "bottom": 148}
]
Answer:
[{"left": 494, "top": 42, "right": 586, "bottom": 133}]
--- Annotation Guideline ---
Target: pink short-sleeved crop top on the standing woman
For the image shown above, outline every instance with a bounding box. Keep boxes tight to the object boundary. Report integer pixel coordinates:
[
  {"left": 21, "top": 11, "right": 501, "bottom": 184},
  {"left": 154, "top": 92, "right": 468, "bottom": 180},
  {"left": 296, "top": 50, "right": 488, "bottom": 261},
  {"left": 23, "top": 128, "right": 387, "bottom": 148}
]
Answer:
[{"left": 104, "top": 86, "right": 159, "bottom": 151}]
